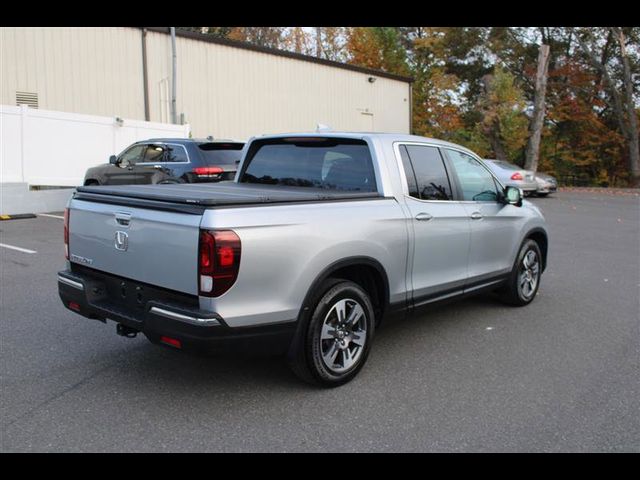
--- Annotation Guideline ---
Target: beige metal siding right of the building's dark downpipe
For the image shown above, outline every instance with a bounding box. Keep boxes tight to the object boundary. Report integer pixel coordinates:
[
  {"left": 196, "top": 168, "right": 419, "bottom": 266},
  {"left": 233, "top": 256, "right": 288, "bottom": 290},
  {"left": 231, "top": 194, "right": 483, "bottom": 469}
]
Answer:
[{"left": 147, "top": 32, "right": 409, "bottom": 140}]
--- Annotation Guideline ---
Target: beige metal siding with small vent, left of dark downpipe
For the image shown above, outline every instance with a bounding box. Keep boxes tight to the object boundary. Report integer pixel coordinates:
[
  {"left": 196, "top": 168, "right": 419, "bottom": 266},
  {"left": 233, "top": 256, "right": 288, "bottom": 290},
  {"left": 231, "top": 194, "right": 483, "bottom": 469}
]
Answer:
[{"left": 0, "top": 27, "right": 144, "bottom": 118}]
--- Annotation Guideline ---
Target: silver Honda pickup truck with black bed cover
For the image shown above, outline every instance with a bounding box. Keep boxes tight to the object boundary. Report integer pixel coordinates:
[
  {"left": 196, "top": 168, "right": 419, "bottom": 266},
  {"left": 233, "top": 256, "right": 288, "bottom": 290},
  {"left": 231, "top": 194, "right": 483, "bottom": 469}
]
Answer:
[{"left": 58, "top": 132, "right": 548, "bottom": 386}]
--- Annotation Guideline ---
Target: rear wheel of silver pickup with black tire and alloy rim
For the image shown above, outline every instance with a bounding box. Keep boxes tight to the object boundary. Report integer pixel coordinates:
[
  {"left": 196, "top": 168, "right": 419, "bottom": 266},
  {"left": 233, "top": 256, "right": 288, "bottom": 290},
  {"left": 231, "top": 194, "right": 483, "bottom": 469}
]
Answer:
[{"left": 288, "top": 279, "right": 375, "bottom": 387}]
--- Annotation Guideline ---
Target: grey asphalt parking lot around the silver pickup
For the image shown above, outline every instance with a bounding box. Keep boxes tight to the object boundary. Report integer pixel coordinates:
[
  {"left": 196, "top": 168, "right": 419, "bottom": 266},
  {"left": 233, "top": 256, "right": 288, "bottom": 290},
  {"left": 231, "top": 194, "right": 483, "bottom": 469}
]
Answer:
[{"left": 0, "top": 192, "right": 640, "bottom": 452}]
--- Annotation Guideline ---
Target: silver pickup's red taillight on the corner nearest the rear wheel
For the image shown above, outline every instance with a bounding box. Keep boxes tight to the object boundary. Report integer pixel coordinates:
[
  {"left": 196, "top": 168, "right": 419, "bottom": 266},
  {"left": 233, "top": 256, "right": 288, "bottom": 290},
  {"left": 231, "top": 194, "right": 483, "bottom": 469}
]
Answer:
[{"left": 198, "top": 230, "right": 241, "bottom": 297}]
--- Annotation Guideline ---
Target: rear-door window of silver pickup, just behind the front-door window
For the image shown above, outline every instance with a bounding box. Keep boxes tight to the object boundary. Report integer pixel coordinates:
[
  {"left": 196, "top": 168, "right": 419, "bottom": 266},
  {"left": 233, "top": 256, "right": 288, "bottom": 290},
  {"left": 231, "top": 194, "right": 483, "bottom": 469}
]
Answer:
[{"left": 400, "top": 145, "right": 453, "bottom": 200}]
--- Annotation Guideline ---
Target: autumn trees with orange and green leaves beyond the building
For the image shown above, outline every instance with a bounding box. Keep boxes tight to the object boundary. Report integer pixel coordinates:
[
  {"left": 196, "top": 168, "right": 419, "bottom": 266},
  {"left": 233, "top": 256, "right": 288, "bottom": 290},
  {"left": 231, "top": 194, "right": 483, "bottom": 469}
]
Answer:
[{"left": 185, "top": 27, "right": 640, "bottom": 185}]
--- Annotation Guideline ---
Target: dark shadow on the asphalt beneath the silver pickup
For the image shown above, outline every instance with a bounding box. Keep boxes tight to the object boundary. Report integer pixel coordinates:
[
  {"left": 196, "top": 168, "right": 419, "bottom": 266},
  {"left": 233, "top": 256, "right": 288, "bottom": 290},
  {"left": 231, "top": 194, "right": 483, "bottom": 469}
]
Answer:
[{"left": 114, "top": 296, "right": 510, "bottom": 397}]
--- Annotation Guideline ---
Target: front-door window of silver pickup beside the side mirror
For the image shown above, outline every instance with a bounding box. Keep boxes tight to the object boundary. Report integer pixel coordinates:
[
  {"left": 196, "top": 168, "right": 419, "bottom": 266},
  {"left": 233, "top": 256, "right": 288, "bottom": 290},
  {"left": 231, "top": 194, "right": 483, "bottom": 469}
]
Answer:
[{"left": 446, "top": 149, "right": 498, "bottom": 202}]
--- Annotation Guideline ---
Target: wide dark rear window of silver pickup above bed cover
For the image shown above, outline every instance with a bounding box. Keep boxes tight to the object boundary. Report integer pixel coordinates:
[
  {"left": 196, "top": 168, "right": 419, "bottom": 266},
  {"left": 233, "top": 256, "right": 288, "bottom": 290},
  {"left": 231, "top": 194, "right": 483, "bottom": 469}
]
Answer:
[{"left": 240, "top": 137, "right": 376, "bottom": 192}]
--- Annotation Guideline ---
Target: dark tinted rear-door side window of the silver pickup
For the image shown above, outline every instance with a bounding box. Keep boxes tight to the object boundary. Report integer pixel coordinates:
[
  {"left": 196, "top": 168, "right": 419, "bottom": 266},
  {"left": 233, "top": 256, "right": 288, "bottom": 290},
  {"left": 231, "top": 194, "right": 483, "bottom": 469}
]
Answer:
[{"left": 405, "top": 145, "right": 452, "bottom": 200}]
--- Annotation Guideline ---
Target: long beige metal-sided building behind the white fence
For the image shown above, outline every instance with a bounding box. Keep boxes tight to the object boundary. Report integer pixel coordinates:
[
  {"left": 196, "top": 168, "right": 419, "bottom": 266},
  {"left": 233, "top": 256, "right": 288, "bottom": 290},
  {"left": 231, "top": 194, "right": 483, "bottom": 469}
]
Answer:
[{"left": 0, "top": 27, "right": 411, "bottom": 139}]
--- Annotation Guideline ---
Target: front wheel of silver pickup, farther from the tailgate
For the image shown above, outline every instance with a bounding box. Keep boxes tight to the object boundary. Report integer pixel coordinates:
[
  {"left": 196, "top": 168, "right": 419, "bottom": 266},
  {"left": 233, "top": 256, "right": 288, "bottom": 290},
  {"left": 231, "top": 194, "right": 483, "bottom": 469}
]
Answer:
[{"left": 496, "top": 238, "right": 542, "bottom": 307}]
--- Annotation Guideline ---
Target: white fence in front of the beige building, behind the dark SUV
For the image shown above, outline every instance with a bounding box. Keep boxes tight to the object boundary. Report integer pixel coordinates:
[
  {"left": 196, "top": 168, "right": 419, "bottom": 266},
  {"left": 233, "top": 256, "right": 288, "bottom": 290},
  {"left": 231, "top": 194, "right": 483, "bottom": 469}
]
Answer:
[{"left": 0, "top": 105, "right": 189, "bottom": 186}]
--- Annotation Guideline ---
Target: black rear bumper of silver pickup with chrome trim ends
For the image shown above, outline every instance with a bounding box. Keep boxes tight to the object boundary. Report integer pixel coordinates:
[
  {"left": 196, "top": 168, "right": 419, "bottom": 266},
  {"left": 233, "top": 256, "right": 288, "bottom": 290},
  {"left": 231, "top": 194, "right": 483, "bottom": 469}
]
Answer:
[{"left": 58, "top": 270, "right": 295, "bottom": 355}]
